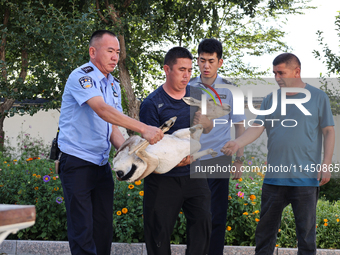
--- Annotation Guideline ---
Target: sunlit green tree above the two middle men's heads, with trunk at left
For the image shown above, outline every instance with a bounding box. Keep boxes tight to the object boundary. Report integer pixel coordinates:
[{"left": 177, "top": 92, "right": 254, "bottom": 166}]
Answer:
[{"left": 92, "top": 0, "right": 309, "bottom": 118}]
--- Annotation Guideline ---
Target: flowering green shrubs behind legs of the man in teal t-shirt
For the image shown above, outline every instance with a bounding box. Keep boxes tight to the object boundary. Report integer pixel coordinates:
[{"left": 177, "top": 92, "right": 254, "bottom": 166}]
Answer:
[{"left": 225, "top": 158, "right": 340, "bottom": 249}]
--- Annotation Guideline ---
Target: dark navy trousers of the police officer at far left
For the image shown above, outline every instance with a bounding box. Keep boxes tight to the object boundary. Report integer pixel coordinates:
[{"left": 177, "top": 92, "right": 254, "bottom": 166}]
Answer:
[{"left": 59, "top": 153, "right": 114, "bottom": 255}]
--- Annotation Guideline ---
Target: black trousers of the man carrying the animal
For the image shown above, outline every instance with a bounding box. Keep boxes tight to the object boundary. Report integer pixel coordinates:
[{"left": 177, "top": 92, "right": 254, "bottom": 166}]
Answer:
[{"left": 143, "top": 174, "right": 211, "bottom": 255}]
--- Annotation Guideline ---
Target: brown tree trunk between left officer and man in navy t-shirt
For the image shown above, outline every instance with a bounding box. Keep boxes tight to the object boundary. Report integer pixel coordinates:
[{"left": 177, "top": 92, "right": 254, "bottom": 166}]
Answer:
[{"left": 118, "top": 35, "right": 139, "bottom": 120}]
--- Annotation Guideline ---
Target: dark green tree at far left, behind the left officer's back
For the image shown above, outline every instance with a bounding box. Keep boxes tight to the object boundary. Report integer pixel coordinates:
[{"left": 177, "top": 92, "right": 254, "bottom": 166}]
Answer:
[{"left": 0, "top": 0, "right": 98, "bottom": 147}]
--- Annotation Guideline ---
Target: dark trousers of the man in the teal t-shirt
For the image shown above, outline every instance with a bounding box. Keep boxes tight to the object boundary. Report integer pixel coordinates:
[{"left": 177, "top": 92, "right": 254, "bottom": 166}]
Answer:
[{"left": 255, "top": 183, "right": 319, "bottom": 255}]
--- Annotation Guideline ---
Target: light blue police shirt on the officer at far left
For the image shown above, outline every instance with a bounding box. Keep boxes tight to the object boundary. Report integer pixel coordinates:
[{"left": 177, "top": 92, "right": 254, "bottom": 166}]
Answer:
[{"left": 58, "top": 61, "right": 123, "bottom": 166}]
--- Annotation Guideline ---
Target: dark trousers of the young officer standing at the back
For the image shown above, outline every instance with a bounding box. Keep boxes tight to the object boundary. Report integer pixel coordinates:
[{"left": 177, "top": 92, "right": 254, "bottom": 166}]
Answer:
[{"left": 200, "top": 156, "right": 231, "bottom": 255}]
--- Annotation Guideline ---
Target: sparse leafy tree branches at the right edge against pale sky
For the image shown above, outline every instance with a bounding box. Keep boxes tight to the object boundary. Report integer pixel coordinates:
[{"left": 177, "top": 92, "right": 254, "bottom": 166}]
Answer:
[{"left": 313, "top": 14, "right": 340, "bottom": 115}]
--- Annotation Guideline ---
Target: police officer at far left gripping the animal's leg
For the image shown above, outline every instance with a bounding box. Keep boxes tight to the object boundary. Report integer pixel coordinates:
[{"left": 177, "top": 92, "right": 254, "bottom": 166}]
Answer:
[{"left": 58, "top": 30, "right": 163, "bottom": 255}]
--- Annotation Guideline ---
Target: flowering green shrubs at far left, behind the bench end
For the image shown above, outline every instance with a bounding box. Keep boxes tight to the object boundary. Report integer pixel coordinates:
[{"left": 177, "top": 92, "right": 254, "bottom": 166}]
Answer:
[{"left": 0, "top": 157, "right": 67, "bottom": 240}]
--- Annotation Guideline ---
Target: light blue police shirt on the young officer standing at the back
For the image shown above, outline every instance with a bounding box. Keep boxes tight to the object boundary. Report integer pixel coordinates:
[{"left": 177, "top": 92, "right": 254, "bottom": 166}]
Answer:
[{"left": 189, "top": 75, "right": 245, "bottom": 160}]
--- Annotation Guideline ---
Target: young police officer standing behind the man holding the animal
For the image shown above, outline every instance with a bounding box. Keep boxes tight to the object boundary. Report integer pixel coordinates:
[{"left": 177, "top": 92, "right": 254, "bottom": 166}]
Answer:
[{"left": 189, "top": 39, "right": 245, "bottom": 255}]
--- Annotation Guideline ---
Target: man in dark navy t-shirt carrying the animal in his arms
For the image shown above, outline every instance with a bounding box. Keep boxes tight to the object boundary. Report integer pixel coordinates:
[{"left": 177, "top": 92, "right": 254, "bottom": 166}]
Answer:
[{"left": 140, "top": 47, "right": 211, "bottom": 255}]
